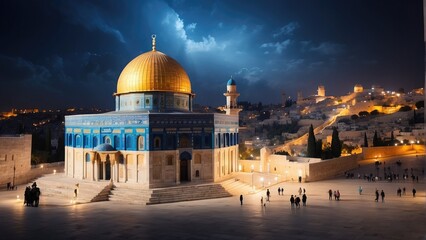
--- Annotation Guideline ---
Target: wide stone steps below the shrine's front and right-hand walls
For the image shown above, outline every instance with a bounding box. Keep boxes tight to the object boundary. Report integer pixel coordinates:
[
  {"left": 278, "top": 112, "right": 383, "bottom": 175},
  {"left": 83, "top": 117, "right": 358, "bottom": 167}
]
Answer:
[{"left": 110, "top": 183, "right": 232, "bottom": 205}]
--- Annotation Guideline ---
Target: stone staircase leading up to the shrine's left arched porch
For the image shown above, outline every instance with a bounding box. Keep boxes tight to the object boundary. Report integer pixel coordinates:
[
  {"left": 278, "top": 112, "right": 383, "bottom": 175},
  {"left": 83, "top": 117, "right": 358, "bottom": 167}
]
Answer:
[{"left": 32, "top": 173, "right": 110, "bottom": 205}]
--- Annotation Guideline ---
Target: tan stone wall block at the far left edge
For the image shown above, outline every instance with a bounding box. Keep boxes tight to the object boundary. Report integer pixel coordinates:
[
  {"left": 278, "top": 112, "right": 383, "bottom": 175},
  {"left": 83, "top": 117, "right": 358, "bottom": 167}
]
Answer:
[{"left": 0, "top": 134, "right": 32, "bottom": 188}]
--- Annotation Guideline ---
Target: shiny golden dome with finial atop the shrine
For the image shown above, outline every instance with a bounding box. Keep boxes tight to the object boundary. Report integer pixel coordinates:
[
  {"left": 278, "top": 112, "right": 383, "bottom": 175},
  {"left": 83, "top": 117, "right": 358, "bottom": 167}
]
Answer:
[{"left": 116, "top": 47, "right": 191, "bottom": 94}]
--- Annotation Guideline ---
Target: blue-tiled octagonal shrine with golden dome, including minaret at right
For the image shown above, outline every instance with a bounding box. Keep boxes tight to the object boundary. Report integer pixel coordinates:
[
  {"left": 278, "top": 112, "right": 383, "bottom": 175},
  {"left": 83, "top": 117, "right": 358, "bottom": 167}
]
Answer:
[{"left": 65, "top": 36, "right": 239, "bottom": 188}]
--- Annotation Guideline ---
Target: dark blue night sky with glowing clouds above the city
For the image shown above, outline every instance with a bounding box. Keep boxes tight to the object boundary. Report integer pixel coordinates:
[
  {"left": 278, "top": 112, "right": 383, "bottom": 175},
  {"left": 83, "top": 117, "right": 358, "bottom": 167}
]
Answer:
[{"left": 0, "top": 0, "right": 424, "bottom": 111}]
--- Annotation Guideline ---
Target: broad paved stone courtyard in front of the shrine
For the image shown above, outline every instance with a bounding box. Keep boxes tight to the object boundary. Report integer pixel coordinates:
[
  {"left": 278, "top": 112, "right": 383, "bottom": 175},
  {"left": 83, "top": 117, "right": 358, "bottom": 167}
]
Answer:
[{"left": 0, "top": 155, "right": 426, "bottom": 239}]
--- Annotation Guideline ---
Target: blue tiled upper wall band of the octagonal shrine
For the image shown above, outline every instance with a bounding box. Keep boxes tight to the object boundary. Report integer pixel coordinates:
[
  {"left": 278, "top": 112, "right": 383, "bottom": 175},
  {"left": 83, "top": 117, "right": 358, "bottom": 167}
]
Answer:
[{"left": 65, "top": 112, "right": 238, "bottom": 151}]
